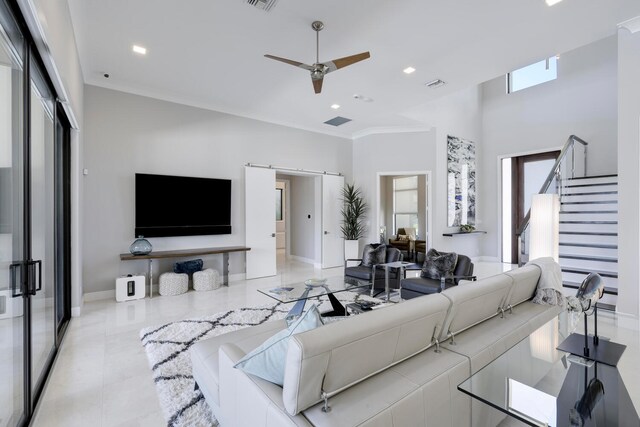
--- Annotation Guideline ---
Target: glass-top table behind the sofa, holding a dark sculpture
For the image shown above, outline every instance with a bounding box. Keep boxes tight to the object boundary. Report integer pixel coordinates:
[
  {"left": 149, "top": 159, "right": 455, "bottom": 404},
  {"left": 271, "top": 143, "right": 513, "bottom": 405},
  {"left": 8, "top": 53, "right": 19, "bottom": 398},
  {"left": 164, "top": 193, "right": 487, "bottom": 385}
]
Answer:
[{"left": 458, "top": 313, "right": 640, "bottom": 427}]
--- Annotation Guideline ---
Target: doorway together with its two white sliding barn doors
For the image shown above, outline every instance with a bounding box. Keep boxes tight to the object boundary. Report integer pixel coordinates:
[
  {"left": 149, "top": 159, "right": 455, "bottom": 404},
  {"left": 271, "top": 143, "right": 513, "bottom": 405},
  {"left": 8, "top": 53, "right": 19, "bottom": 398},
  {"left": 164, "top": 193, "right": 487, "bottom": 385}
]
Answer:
[{"left": 245, "top": 164, "right": 344, "bottom": 279}]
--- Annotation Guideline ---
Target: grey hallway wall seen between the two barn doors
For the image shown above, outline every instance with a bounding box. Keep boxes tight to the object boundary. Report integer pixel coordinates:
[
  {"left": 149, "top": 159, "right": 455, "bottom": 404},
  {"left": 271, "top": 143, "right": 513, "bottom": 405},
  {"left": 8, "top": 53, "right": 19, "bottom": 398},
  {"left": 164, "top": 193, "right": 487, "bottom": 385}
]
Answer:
[{"left": 290, "top": 176, "right": 320, "bottom": 263}]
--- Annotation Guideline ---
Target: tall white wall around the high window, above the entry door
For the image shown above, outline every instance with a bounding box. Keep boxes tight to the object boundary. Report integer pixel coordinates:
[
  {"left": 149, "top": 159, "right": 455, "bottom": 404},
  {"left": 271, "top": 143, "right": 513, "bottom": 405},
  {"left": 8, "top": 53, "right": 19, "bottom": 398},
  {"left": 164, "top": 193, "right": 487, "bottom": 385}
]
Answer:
[{"left": 478, "top": 37, "right": 618, "bottom": 257}]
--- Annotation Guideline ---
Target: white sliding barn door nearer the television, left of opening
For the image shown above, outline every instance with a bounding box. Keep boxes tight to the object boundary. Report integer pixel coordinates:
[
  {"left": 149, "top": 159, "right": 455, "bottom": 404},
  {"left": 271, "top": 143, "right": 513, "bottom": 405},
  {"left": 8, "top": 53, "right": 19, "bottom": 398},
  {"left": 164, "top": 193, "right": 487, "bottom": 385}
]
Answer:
[{"left": 244, "top": 166, "right": 276, "bottom": 279}]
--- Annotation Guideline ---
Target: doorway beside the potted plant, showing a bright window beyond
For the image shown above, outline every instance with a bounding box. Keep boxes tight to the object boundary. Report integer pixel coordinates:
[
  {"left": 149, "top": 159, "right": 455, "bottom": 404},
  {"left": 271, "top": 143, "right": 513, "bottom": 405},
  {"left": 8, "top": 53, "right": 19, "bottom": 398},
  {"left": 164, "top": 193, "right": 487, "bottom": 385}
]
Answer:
[{"left": 375, "top": 171, "right": 432, "bottom": 257}]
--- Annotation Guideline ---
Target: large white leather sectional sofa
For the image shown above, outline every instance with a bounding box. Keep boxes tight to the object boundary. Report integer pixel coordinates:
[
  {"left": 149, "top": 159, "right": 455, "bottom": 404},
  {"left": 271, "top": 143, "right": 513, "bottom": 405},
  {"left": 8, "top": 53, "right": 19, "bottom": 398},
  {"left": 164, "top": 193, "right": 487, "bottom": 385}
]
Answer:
[{"left": 191, "top": 266, "right": 561, "bottom": 427}]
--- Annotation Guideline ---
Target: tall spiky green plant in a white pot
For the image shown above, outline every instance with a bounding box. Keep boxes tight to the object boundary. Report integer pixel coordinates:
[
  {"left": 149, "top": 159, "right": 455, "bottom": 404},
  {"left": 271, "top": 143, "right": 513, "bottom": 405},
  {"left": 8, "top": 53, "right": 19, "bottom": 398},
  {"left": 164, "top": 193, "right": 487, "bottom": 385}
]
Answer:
[{"left": 340, "top": 184, "right": 367, "bottom": 259}]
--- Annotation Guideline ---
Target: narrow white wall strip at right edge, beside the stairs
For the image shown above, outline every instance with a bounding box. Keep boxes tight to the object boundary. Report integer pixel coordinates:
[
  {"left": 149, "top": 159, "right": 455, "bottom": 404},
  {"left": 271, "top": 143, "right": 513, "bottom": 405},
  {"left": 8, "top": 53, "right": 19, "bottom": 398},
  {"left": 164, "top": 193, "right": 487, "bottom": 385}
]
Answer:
[{"left": 616, "top": 29, "right": 640, "bottom": 316}]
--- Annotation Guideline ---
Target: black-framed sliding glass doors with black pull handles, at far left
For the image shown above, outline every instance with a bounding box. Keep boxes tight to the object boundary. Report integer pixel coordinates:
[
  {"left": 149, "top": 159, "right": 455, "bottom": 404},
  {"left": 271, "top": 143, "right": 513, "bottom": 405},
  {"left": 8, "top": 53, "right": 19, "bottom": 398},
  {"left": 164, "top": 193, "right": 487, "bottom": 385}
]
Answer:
[{"left": 0, "top": 0, "right": 70, "bottom": 427}]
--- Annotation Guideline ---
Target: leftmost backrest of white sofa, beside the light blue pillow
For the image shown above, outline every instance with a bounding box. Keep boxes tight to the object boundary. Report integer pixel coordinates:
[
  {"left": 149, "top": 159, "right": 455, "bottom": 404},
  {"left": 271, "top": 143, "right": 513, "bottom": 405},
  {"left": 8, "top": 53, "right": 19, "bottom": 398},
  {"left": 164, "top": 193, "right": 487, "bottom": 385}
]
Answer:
[{"left": 283, "top": 295, "right": 449, "bottom": 415}]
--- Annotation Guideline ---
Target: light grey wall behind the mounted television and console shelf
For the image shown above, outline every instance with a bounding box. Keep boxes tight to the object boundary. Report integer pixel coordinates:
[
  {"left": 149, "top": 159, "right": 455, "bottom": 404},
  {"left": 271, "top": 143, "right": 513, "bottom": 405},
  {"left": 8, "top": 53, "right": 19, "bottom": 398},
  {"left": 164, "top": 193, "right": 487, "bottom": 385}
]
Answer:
[{"left": 83, "top": 86, "right": 351, "bottom": 292}]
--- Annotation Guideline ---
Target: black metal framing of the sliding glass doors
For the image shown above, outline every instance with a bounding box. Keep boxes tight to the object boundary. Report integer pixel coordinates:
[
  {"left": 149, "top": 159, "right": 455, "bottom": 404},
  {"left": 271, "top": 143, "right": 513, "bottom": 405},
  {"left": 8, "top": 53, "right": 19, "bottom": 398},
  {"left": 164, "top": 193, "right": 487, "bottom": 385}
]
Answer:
[{"left": 0, "top": 0, "right": 71, "bottom": 426}]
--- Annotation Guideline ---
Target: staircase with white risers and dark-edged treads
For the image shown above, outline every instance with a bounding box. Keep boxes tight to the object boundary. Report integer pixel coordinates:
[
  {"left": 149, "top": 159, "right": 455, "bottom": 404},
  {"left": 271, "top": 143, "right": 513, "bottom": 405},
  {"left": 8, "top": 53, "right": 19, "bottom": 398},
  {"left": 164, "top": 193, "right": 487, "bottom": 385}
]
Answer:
[{"left": 559, "top": 175, "right": 618, "bottom": 308}]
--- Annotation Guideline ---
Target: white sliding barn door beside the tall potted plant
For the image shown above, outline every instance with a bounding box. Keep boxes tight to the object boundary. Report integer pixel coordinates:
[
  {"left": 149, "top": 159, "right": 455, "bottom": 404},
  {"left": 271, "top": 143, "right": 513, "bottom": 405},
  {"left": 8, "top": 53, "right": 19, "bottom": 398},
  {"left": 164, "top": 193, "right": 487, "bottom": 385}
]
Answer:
[{"left": 322, "top": 175, "right": 344, "bottom": 268}]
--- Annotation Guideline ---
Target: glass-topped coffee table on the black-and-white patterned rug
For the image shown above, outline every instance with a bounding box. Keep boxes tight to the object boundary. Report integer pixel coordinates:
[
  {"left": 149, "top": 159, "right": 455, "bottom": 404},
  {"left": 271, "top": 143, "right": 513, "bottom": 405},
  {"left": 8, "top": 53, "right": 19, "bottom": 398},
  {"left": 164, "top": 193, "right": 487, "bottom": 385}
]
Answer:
[{"left": 258, "top": 276, "right": 370, "bottom": 319}]
